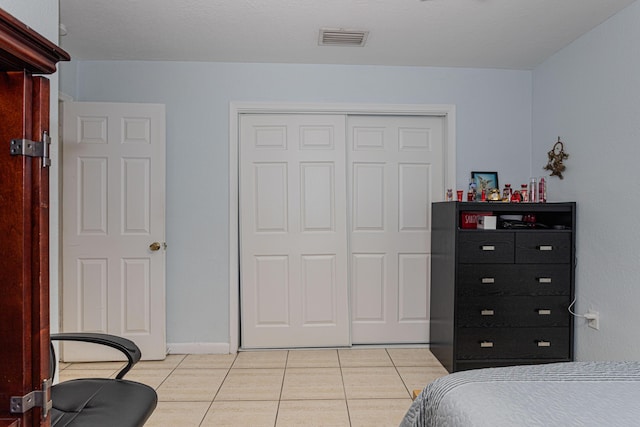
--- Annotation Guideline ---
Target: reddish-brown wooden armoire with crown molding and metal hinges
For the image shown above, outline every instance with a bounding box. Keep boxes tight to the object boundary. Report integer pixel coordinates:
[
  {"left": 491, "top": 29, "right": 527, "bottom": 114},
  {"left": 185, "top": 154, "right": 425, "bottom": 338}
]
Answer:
[{"left": 0, "top": 9, "right": 70, "bottom": 427}]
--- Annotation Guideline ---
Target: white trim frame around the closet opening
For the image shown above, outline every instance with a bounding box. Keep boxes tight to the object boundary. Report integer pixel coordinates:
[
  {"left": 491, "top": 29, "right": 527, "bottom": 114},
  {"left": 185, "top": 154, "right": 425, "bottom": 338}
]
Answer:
[{"left": 229, "top": 101, "right": 456, "bottom": 353}]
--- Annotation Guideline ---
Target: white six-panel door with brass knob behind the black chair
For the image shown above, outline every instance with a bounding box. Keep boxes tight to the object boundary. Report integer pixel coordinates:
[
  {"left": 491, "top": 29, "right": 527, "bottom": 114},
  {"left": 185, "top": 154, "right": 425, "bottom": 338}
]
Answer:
[{"left": 62, "top": 102, "right": 166, "bottom": 361}]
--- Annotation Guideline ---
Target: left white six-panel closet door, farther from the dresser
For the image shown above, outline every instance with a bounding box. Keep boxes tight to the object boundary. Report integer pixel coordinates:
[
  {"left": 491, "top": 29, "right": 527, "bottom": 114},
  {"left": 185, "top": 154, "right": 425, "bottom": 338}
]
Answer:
[{"left": 239, "top": 114, "right": 350, "bottom": 348}]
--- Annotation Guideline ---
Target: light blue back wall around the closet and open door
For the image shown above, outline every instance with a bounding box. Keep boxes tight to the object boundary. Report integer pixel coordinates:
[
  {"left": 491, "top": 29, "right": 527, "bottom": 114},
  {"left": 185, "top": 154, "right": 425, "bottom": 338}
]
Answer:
[{"left": 62, "top": 61, "right": 532, "bottom": 343}]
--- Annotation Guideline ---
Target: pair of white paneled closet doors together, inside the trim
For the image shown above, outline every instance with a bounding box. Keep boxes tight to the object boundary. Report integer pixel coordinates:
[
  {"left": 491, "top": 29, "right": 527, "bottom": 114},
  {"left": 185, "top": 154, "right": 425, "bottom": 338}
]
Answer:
[{"left": 239, "top": 114, "right": 444, "bottom": 348}]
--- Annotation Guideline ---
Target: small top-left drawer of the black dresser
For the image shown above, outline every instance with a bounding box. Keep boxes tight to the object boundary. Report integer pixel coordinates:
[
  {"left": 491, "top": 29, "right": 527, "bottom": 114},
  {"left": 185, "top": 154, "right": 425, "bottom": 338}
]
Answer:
[{"left": 458, "top": 231, "right": 515, "bottom": 263}]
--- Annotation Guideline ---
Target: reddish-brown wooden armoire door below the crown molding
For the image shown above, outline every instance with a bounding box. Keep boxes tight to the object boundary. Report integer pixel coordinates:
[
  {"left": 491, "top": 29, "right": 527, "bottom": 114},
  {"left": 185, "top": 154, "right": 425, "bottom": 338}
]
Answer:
[{"left": 0, "top": 72, "right": 50, "bottom": 426}]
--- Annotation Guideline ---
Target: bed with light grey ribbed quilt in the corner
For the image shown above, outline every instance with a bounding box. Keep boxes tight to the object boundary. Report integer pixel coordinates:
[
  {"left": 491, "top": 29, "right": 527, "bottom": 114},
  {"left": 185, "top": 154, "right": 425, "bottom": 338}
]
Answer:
[{"left": 400, "top": 362, "right": 640, "bottom": 427}]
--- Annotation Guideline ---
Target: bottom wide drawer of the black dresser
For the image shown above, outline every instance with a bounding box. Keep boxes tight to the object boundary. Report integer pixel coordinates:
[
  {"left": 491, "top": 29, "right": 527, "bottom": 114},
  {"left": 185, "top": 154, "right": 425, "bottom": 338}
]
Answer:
[{"left": 456, "top": 328, "right": 570, "bottom": 360}]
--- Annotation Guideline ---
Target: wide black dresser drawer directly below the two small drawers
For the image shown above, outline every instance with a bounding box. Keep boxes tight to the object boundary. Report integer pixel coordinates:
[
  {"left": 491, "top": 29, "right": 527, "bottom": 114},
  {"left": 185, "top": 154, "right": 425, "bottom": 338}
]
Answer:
[{"left": 457, "top": 264, "right": 571, "bottom": 297}]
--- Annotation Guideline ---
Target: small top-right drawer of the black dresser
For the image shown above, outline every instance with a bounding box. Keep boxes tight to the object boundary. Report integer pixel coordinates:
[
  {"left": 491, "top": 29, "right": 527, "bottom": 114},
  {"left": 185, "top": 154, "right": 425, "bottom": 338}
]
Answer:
[{"left": 515, "top": 231, "right": 571, "bottom": 264}]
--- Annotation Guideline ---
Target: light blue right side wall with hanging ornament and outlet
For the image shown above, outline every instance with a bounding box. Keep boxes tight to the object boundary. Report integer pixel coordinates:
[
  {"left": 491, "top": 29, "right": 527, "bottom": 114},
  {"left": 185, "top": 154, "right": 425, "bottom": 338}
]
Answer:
[{"left": 532, "top": 2, "right": 640, "bottom": 360}]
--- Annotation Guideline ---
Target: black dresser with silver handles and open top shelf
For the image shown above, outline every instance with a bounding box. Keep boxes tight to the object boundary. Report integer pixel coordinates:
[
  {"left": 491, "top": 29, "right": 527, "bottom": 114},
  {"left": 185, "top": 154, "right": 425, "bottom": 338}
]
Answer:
[{"left": 429, "top": 202, "right": 576, "bottom": 372}]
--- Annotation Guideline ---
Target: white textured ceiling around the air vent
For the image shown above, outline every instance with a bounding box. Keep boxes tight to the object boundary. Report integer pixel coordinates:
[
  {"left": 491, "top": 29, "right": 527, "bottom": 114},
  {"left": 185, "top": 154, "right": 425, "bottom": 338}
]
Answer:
[{"left": 60, "top": 0, "right": 635, "bottom": 69}]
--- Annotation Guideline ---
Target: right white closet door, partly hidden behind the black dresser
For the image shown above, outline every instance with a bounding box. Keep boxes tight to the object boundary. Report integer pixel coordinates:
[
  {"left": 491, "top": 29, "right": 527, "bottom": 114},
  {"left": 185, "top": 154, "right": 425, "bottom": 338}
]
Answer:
[{"left": 347, "top": 116, "right": 444, "bottom": 344}]
